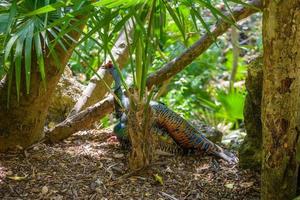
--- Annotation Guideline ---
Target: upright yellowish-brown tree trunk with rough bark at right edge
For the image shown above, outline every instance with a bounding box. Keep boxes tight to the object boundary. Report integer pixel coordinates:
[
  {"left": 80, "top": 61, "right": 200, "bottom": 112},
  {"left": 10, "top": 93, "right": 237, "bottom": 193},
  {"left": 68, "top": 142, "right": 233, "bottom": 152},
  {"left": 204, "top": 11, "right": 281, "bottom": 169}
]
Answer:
[{"left": 261, "top": 0, "right": 300, "bottom": 200}]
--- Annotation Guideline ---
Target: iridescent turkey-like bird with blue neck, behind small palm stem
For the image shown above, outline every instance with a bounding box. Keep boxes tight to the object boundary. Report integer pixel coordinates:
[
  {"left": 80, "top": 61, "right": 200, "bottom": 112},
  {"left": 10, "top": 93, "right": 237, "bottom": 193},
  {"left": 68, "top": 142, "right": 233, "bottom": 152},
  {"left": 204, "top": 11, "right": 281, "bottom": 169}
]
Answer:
[{"left": 102, "top": 61, "right": 238, "bottom": 164}]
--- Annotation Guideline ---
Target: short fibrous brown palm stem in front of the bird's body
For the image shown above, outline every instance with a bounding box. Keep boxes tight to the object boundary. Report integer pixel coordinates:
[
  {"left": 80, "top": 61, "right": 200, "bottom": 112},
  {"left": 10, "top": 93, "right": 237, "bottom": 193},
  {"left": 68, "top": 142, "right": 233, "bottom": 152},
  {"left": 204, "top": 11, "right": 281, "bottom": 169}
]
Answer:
[{"left": 127, "top": 94, "right": 155, "bottom": 171}]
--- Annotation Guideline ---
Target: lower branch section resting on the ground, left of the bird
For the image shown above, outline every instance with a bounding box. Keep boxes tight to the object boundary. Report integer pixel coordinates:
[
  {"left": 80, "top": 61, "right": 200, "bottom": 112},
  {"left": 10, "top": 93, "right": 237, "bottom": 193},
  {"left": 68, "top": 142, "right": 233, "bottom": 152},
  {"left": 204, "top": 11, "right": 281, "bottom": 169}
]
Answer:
[{"left": 45, "top": 96, "right": 114, "bottom": 143}]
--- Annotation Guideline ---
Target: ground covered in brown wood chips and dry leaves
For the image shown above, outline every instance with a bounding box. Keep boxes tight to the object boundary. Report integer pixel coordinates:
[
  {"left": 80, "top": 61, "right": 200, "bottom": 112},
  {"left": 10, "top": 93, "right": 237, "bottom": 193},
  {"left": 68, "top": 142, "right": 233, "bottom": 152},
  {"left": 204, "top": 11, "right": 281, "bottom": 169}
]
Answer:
[{"left": 0, "top": 130, "right": 259, "bottom": 200}]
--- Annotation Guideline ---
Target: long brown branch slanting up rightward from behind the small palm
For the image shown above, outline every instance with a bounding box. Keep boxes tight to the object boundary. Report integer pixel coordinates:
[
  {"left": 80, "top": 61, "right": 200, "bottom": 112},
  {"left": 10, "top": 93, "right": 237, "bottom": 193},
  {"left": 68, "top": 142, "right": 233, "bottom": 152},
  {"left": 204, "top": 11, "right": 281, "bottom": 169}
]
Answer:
[{"left": 147, "top": 0, "right": 262, "bottom": 88}]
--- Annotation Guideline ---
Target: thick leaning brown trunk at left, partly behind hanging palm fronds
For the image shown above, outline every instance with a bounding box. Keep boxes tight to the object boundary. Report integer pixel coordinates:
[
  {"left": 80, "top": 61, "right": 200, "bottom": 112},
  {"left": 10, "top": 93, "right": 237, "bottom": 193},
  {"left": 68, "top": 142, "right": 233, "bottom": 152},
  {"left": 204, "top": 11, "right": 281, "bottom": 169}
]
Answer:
[{"left": 0, "top": 19, "right": 83, "bottom": 152}]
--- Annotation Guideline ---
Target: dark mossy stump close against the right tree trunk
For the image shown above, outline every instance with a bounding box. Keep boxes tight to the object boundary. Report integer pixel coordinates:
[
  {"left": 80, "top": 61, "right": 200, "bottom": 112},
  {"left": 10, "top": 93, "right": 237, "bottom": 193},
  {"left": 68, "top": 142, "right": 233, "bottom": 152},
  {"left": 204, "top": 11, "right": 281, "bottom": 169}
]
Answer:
[{"left": 239, "top": 57, "right": 263, "bottom": 170}]
